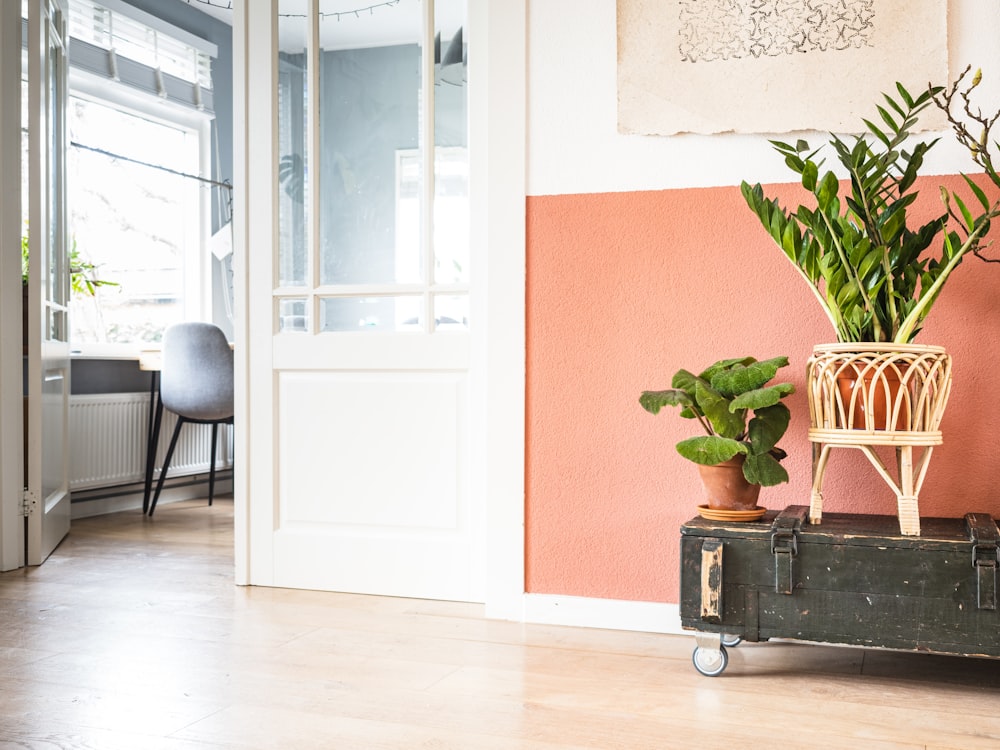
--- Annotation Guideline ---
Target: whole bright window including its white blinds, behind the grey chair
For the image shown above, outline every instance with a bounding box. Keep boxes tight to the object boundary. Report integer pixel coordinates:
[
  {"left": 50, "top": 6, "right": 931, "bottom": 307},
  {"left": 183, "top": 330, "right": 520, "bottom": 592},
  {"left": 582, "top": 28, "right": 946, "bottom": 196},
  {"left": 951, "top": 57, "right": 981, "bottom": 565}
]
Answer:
[{"left": 56, "top": 0, "right": 217, "bottom": 355}]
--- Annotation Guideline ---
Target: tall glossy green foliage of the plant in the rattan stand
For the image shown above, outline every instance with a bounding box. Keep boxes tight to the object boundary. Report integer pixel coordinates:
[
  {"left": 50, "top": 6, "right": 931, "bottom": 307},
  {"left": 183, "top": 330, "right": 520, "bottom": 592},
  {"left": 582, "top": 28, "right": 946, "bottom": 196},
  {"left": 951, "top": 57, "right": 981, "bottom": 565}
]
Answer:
[{"left": 741, "top": 83, "right": 989, "bottom": 344}]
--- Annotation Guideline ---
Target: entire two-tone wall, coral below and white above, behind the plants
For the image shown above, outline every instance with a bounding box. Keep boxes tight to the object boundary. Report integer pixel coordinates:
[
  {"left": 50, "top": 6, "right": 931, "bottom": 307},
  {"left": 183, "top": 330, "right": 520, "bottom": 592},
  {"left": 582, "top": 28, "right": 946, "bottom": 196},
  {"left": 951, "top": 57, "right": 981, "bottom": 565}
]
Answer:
[{"left": 525, "top": 0, "right": 1000, "bottom": 609}]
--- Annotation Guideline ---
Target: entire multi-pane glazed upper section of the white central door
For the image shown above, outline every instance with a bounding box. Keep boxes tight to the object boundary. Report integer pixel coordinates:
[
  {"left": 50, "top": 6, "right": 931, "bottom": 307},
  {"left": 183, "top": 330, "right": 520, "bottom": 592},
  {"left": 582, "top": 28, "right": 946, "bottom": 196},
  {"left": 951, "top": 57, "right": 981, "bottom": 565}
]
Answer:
[{"left": 275, "top": 0, "right": 470, "bottom": 332}]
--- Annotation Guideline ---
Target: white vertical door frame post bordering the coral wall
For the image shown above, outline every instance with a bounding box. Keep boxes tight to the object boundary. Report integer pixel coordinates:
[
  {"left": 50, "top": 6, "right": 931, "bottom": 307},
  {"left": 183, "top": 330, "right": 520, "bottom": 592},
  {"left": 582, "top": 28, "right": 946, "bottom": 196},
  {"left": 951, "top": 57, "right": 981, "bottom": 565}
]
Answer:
[{"left": 469, "top": 0, "right": 527, "bottom": 620}]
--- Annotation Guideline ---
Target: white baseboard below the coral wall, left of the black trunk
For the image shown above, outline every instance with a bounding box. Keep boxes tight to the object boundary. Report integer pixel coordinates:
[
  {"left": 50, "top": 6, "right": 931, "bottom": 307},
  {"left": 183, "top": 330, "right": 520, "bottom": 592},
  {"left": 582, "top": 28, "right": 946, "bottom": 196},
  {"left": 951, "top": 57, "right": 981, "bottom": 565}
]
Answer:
[{"left": 524, "top": 594, "right": 690, "bottom": 635}]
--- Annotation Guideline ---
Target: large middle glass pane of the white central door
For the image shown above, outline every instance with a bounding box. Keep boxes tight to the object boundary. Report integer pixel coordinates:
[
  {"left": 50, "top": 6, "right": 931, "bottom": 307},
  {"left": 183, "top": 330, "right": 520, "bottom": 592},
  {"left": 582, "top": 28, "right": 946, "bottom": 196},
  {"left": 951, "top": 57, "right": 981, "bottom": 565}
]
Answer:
[{"left": 318, "top": 0, "right": 425, "bottom": 286}]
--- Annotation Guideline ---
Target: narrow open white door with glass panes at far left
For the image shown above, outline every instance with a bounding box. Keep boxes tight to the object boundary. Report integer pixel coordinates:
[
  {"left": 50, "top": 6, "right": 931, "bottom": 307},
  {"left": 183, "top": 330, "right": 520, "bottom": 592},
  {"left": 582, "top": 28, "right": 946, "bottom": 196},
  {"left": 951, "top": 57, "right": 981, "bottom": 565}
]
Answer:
[{"left": 26, "top": 0, "right": 70, "bottom": 565}]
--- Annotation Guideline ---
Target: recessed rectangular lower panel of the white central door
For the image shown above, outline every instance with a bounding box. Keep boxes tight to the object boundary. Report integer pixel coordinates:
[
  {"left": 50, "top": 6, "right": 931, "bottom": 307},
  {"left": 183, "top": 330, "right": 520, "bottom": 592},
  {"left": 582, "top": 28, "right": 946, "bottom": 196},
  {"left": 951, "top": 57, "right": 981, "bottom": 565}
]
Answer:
[{"left": 278, "top": 372, "right": 466, "bottom": 533}]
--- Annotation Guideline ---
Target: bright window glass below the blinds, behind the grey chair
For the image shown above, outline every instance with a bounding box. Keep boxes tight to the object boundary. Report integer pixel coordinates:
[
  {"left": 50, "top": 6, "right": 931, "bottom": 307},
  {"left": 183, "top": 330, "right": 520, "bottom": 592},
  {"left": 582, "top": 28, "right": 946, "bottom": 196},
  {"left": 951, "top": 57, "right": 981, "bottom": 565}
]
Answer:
[{"left": 67, "top": 95, "right": 204, "bottom": 351}]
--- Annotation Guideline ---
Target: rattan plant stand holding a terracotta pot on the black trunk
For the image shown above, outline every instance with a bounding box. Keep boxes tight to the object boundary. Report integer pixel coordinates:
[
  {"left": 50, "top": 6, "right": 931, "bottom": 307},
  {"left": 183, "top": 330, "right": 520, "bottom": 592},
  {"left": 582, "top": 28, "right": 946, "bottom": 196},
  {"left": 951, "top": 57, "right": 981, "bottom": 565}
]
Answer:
[{"left": 806, "top": 343, "right": 951, "bottom": 536}]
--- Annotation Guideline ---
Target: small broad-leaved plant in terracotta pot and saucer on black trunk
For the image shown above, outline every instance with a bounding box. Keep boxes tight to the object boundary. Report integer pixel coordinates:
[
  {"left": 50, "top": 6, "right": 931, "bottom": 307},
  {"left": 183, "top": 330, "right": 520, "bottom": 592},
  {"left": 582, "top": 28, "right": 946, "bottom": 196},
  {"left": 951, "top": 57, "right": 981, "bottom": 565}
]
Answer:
[{"left": 639, "top": 357, "right": 795, "bottom": 521}]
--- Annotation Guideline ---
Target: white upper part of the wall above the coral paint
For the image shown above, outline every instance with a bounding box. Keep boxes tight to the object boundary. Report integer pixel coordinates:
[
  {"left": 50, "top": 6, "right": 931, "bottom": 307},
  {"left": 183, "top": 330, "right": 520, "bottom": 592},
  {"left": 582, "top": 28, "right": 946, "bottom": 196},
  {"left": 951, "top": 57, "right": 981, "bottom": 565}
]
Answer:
[{"left": 528, "top": 0, "right": 1000, "bottom": 195}]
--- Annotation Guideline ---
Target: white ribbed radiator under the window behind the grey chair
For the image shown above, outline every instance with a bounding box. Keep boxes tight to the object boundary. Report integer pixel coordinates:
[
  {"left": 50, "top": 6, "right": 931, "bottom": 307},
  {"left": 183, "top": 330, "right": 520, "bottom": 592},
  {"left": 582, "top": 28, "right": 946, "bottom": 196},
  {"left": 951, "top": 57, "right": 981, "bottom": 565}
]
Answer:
[{"left": 69, "top": 393, "right": 232, "bottom": 490}]
